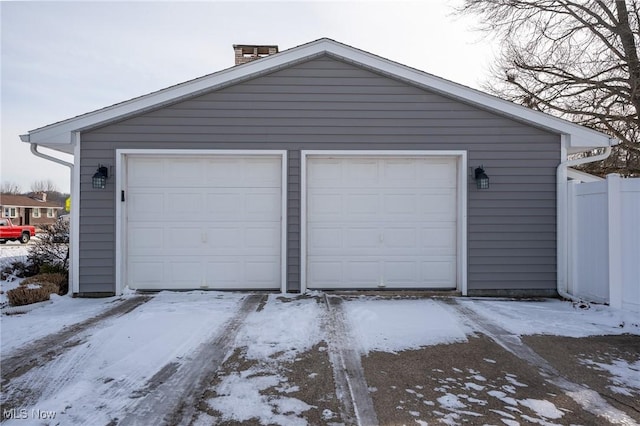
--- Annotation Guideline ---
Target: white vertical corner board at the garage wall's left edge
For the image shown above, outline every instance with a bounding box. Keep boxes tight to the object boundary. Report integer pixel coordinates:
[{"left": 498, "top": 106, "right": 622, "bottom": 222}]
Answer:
[{"left": 69, "top": 132, "right": 82, "bottom": 294}]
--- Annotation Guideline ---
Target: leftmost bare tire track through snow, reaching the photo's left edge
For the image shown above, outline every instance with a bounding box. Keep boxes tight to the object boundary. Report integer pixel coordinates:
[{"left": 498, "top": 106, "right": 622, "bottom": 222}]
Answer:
[{"left": 2, "top": 296, "right": 151, "bottom": 389}]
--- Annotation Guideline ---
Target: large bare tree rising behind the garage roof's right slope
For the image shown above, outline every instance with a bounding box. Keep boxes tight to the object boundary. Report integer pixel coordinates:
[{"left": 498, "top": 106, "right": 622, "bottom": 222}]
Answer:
[{"left": 458, "top": 0, "right": 640, "bottom": 175}]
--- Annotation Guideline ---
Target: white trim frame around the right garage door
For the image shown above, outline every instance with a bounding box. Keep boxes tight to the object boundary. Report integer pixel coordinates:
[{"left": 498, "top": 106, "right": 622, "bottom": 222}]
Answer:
[{"left": 300, "top": 150, "right": 468, "bottom": 296}]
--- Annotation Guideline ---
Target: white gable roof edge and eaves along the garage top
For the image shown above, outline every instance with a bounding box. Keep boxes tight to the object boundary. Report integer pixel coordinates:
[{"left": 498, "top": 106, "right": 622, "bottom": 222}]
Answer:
[{"left": 20, "top": 38, "right": 617, "bottom": 154}]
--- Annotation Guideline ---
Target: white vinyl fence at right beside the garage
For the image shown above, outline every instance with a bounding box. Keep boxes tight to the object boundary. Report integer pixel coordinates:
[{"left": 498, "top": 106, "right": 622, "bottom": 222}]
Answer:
[{"left": 569, "top": 175, "right": 640, "bottom": 313}]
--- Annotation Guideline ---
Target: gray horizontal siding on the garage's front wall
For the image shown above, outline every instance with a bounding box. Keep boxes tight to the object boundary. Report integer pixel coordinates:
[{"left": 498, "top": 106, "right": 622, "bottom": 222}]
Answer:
[{"left": 80, "top": 57, "right": 560, "bottom": 292}]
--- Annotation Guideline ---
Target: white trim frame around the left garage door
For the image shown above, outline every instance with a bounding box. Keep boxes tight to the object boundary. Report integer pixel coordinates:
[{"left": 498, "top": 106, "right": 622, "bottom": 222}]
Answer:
[{"left": 115, "top": 149, "right": 287, "bottom": 294}]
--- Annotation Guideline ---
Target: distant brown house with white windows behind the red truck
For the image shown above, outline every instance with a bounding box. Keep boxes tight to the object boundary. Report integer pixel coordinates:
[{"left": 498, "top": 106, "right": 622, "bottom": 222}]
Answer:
[{"left": 0, "top": 193, "right": 62, "bottom": 227}]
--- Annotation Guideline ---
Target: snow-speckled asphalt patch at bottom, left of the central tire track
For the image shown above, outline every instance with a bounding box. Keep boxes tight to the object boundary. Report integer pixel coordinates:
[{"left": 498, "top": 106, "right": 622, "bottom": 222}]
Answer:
[{"left": 198, "top": 342, "right": 344, "bottom": 426}]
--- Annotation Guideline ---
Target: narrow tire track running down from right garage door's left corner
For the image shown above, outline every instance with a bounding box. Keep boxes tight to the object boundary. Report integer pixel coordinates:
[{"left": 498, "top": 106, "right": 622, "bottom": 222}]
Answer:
[{"left": 324, "top": 294, "right": 378, "bottom": 426}]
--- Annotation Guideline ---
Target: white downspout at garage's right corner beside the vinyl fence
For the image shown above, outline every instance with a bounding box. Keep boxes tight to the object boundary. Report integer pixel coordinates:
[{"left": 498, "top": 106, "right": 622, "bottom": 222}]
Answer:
[{"left": 556, "top": 141, "right": 616, "bottom": 301}]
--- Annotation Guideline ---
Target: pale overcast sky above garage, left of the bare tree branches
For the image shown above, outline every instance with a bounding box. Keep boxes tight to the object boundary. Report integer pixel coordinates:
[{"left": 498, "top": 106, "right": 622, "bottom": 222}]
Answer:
[{"left": 0, "top": 0, "right": 495, "bottom": 192}]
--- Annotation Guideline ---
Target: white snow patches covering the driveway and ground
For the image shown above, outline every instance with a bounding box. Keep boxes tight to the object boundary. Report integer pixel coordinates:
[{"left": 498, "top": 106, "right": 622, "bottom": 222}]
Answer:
[{"left": 0, "top": 246, "right": 640, "bottom": 425}]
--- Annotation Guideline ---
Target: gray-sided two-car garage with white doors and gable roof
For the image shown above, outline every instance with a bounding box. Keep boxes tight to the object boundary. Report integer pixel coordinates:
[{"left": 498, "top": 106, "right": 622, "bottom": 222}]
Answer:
[{"left": 22, "top": 39, "right": 615, "bottom": 295}]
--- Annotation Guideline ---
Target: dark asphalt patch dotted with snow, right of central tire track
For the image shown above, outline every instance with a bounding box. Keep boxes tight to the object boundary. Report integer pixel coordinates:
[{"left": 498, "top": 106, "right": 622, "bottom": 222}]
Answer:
[{"left": 362, "top": 334, "right": 602, "bottom": 425}]
